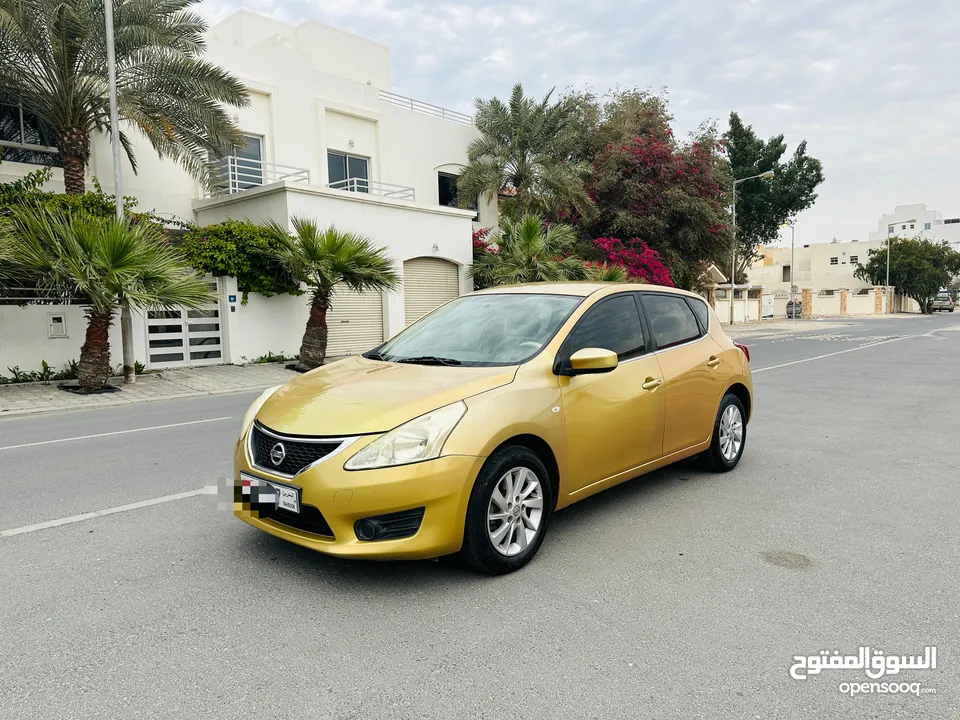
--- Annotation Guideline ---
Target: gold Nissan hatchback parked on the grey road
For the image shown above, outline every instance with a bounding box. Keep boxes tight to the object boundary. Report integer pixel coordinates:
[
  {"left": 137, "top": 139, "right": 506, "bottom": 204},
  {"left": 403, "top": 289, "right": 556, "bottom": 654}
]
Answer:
[{"left": 234, "top": 283, "right": 753, "bottom": 573}]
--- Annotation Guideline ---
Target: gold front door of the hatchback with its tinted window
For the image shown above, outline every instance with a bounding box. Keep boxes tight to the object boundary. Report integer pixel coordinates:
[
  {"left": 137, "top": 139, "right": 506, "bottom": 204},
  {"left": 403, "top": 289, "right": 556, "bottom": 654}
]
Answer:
[{"left": 559, "top": 292, "right": 664, "bottom": 492}]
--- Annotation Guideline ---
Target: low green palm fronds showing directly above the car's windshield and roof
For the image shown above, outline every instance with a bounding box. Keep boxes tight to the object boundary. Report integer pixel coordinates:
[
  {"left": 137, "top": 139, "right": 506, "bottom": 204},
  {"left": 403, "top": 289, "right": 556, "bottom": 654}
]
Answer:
[{"left": 471, "top": 214, "right": 588, "bottom": 287}]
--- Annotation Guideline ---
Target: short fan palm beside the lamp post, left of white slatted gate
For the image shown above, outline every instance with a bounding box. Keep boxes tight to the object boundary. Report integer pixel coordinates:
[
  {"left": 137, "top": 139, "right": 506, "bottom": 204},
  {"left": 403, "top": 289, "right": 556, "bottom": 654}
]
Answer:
[{"left": 0, "top": 208, "right": 216, "bottom": 391}]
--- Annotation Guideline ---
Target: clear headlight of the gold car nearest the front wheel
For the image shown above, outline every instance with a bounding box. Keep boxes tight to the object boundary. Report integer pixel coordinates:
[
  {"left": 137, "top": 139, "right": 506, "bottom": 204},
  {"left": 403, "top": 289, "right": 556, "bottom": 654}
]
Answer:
[{"left": 343, "top": 400, "right": 467, "bottom": 470}]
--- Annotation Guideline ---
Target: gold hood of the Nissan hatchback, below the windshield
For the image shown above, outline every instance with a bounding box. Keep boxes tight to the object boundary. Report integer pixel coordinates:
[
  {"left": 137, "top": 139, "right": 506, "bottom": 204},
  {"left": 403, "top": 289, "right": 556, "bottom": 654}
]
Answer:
[{"left": 251, "top": 357, "right": 517, "bottom": 436}]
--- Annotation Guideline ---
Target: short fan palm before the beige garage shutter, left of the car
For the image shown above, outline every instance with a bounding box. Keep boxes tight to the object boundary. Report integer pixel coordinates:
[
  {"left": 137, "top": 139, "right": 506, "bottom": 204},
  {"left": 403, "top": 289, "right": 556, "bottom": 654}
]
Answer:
[{"left": 266, "top": 217, "right": 400, "bottom": 370}]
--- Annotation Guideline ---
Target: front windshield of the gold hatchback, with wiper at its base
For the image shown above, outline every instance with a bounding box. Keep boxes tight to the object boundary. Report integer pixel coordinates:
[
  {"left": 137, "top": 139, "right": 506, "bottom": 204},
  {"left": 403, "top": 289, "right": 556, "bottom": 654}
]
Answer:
[{"left": 364, "top": 293, "right": 583, "bottom": 366}]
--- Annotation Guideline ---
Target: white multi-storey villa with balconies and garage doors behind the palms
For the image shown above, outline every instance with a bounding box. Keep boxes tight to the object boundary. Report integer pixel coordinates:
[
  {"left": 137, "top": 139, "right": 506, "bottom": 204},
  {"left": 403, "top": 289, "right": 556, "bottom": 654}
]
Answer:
[{"left": 0, "top": 11, "right": 496, "bottom": 369}]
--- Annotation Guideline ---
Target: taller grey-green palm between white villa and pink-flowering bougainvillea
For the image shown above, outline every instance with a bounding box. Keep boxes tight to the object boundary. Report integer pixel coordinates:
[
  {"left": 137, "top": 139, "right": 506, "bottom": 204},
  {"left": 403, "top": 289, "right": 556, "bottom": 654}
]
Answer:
[{"left": 458, "top": 83, "right": 593, "bottom": 218}]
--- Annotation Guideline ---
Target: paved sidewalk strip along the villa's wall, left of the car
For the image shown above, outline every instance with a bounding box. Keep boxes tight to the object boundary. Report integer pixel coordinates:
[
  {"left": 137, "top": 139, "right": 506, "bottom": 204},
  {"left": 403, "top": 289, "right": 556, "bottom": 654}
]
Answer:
[{"left": 0, "top": 363, "right": 297, "bottom": 418}]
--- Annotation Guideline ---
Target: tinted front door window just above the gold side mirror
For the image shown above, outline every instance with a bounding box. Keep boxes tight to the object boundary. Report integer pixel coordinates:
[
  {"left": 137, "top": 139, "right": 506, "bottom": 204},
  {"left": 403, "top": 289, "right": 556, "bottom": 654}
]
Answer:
[{"left": 564, "top": 293, "right": 646, "bottom": 361}]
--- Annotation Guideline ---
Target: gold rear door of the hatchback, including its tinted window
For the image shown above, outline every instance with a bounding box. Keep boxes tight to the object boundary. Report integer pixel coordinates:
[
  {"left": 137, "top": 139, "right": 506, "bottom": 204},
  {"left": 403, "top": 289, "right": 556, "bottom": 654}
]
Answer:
[{"left": 641, "top": 292, "right": 726, "bottom": 456}]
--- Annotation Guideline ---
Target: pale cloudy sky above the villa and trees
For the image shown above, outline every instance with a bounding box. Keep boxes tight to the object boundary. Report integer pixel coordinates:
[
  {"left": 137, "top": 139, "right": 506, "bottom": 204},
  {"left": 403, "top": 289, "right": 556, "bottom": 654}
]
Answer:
[{"left": 199, "top": 0, "right": 960, "bottom": 245}]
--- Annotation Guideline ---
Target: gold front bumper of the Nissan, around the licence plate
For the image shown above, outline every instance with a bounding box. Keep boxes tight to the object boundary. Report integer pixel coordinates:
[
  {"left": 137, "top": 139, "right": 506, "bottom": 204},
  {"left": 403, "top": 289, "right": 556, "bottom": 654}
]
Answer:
[{"left": 233, "top": 430, "right": 484, "bottom": 560}]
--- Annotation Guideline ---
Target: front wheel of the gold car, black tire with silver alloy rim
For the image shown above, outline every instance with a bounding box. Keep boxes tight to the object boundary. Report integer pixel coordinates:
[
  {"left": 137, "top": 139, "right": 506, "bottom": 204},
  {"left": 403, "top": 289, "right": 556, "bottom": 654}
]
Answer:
[{"left": 460, "top": 446, "right": 553, "bottom": 575}]
